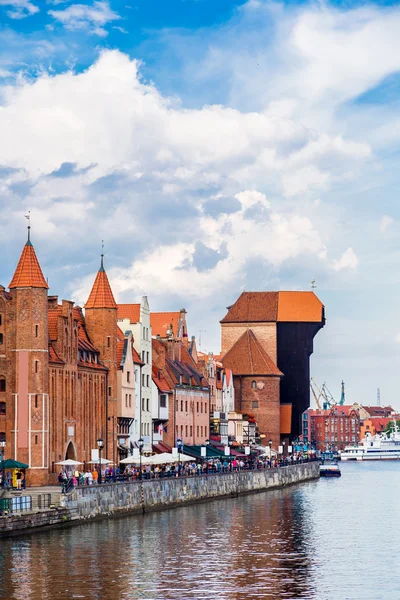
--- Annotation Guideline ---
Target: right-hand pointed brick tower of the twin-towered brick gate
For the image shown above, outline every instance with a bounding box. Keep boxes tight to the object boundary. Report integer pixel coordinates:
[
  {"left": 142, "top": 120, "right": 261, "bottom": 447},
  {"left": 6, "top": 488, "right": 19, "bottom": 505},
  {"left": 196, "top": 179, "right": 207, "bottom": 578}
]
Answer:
[{"left": 85, "top": 254, "right": 117, "bottom": 460}]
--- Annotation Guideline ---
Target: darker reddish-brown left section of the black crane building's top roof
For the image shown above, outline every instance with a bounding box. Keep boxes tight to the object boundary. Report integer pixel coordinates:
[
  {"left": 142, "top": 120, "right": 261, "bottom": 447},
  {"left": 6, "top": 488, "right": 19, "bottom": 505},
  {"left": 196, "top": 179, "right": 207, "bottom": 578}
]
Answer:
[{"left": 221, "top": 292, "right": 278, "bottom": 323}]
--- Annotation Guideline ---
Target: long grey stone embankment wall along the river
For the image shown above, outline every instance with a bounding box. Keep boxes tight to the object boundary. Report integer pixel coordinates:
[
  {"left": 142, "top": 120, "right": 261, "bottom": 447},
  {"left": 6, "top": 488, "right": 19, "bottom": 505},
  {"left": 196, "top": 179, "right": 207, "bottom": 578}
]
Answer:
[{"left": 0, "top": 462, "right": 319, "bottom": 536}]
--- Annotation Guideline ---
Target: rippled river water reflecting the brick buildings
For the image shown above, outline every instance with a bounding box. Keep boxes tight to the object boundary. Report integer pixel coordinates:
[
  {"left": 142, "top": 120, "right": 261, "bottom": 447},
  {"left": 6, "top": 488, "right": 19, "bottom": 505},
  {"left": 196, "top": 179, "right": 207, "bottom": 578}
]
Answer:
[{"left": 0, "top": 462, "right": 400, "bottom": 600}]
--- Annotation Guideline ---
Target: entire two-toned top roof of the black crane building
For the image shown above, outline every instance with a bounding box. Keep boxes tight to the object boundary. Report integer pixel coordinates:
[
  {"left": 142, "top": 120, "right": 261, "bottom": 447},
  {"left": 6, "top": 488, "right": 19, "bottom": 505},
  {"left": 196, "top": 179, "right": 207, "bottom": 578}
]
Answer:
[{"left": 221, "top": 292, "right": 324, "bottom": 323}]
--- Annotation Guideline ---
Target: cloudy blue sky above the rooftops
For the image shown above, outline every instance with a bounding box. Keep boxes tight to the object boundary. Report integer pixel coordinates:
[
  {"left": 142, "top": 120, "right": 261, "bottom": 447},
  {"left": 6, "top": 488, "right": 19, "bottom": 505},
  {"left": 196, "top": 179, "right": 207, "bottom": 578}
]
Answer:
[{"left": 0, "top": 0, "right": 400, "bottom": 408}]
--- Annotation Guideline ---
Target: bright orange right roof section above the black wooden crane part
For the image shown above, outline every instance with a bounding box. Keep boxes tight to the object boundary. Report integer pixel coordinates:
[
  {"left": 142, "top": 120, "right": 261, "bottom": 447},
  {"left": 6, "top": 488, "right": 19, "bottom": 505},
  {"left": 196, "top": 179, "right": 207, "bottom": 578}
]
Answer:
[{"left": 278, "top": 292, "right": 324, "bottom": 323}]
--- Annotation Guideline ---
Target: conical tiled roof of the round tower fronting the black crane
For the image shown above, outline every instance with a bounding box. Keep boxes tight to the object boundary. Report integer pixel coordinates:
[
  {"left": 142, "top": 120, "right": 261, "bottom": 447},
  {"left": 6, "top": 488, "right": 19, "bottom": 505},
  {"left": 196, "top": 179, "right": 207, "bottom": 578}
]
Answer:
[{"left": 222, "top": 329, "right": 282, "bottom": 377}]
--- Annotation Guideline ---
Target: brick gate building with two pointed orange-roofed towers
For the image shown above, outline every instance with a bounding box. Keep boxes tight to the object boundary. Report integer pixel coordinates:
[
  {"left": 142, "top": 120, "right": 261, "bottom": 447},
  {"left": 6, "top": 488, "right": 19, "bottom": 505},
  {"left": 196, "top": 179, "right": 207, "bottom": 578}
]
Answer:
[{"left": 0, "top": 228, "right": 118, "bottom": 485}]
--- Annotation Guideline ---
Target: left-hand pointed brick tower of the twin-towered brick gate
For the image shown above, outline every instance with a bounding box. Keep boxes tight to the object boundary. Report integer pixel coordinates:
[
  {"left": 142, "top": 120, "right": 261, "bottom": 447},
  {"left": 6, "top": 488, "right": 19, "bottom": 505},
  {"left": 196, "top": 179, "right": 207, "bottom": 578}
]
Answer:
[{"left": 7, "top": 226, "right": 49, "bottom": 485}]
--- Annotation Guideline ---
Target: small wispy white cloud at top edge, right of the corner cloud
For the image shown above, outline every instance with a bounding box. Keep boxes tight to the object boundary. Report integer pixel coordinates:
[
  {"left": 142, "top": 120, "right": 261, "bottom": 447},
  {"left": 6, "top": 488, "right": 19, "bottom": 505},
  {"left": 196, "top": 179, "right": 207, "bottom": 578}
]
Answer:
[{"left": 49, "top": 0, "right": 120, "bottom": 37}]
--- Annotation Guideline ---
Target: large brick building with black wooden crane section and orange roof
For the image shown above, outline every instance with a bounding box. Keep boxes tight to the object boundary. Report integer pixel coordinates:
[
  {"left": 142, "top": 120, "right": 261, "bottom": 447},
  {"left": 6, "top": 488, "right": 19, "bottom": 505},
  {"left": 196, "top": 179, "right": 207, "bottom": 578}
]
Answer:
[{"left": 221, "top": 292, "right": 325, "bottom": 447}]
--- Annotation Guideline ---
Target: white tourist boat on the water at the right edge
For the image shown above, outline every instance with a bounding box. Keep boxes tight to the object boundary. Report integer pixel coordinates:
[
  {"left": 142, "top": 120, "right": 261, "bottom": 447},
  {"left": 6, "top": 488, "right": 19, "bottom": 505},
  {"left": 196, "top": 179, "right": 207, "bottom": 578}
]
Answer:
[{"left": 340, "top": 420, "right": 400, "bottom": 460}]
